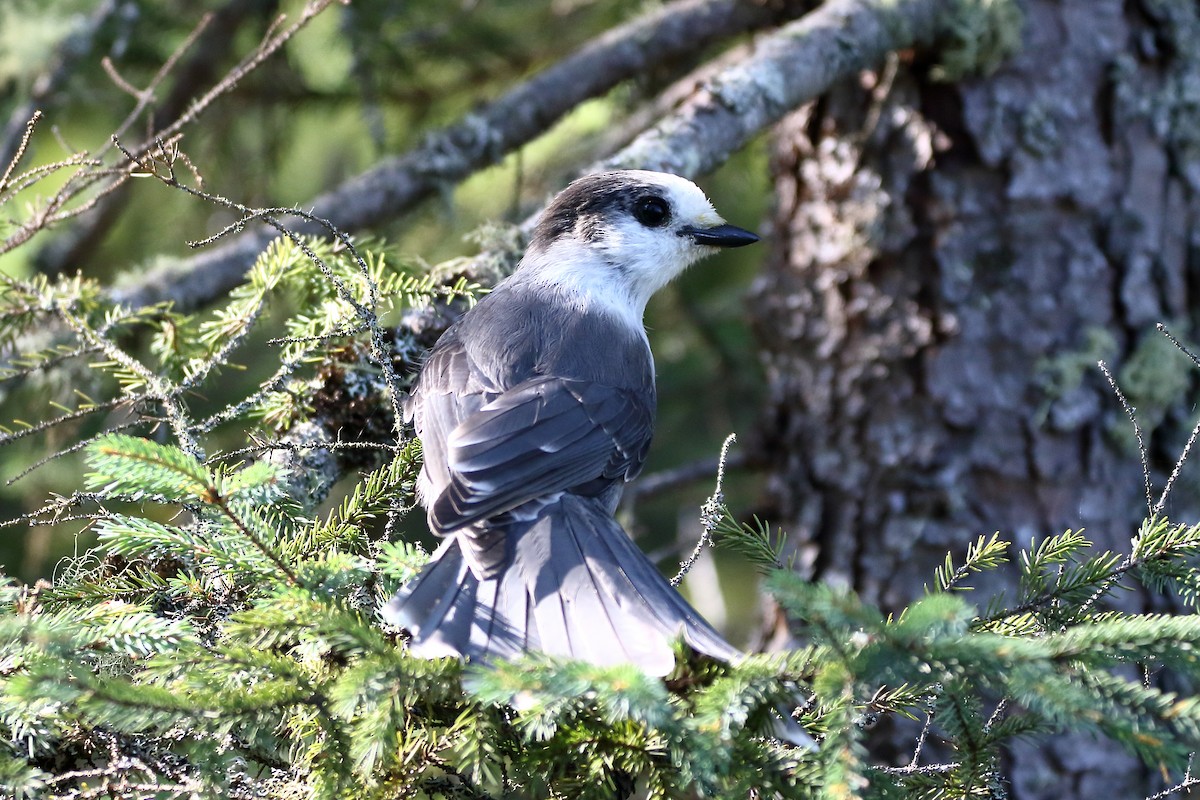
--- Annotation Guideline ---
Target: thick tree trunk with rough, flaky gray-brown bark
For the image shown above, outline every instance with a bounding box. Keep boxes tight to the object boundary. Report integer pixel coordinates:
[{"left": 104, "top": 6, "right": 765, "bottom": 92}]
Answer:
[{"left": 751, "top": 0, "right": 1200, "bottom": 800}]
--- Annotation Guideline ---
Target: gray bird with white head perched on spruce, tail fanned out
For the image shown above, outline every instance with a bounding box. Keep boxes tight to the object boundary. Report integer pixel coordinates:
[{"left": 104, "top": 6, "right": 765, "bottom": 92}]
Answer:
[{"left": 384, "top": 170, "right": 758, "bottom": 676}]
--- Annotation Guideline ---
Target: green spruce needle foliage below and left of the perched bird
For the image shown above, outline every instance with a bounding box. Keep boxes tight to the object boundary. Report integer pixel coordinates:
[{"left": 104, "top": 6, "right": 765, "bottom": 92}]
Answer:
[{"left": 7, "top": 120, "right": 1200, "bottom": 800}]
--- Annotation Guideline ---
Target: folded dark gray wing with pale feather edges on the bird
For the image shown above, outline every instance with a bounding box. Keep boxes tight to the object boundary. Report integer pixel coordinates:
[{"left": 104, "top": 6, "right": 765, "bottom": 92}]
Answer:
[{"left": 430, "top": 377, "right": 654, "bottom": 533}]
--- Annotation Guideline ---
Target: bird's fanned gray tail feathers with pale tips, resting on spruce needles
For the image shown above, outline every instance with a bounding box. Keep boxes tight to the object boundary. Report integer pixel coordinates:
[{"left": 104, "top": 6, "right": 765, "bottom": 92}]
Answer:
[{"left": 384, "top": 494, "right": 740, "bottom": 675}]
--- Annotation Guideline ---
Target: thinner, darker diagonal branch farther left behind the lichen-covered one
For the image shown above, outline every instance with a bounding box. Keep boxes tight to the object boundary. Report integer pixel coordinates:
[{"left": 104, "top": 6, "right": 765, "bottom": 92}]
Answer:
[{"left": 113, "top": 0, "right": 799, "bottom": 311}]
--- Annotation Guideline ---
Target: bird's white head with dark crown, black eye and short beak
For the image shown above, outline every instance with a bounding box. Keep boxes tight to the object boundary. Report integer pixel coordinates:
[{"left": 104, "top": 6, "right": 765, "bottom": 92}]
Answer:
[{"left": 522, "top": 169, "right": 758, "bottom": 318}]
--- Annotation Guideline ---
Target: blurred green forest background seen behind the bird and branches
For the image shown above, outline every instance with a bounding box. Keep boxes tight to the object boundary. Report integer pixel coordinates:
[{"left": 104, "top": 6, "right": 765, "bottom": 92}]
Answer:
[{"left": 0, "top": 0, "right": 770, "bottom": 639}]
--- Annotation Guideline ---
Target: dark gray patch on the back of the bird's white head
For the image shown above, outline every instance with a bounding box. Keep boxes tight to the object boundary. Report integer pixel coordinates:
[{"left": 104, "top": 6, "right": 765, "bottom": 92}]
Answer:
[{"left": 530, "top": 172, "right": 662, "bottom": 247}]
